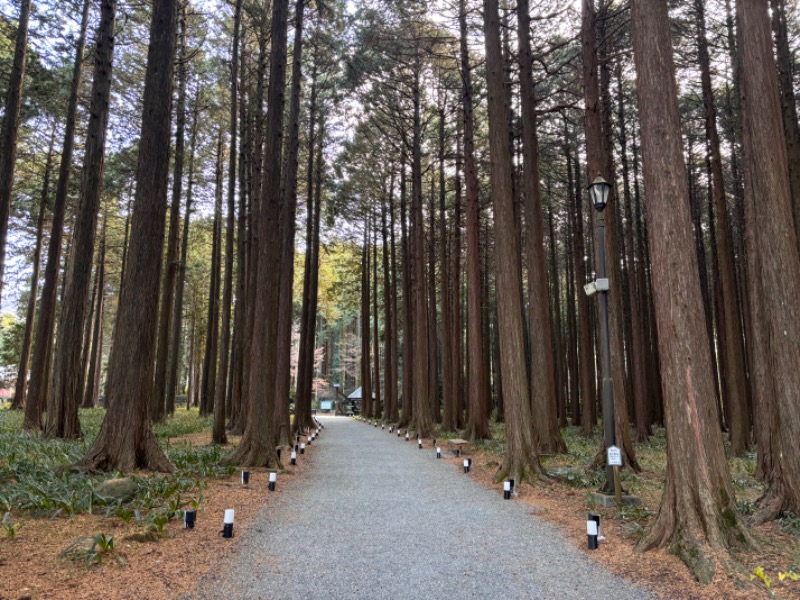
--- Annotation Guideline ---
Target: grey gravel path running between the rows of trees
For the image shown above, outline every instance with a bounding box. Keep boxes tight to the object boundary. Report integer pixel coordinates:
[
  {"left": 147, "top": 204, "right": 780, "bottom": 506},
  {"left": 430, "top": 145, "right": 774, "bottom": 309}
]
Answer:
[{"left": 190, "top": 417, "right": 650, "bottom": 600}]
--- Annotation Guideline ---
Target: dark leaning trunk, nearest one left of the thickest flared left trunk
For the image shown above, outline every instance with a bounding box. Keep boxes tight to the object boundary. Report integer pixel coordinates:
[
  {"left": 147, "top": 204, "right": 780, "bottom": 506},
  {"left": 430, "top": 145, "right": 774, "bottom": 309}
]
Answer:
[{"left": 46, "top": 0, "right": 116, "bottom": 439}]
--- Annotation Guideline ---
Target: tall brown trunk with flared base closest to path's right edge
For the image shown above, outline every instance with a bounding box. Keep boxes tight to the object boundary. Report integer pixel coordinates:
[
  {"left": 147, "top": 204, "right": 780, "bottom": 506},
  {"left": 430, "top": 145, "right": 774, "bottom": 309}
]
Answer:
[{"left": 483, "top": 0, "right": 544, "bottom": 482}]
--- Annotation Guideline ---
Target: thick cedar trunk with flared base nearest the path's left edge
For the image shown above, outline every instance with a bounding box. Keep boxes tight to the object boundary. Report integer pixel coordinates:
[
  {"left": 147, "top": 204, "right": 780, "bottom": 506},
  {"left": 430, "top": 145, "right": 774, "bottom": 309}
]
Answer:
[{"left": 226, "top": 0, "right": 289, "bottom": 467}]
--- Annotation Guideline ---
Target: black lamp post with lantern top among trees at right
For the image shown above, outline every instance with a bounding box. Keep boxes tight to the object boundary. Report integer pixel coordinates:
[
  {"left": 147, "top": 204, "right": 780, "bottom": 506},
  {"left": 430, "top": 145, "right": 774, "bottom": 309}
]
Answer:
[{"left": 587, "top": 175, "right": 616, "bottom": 494}]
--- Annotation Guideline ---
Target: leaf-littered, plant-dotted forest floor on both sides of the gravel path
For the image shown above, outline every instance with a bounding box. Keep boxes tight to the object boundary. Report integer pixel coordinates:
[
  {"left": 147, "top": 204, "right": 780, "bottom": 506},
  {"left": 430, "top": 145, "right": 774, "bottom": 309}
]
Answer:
[{"left": 0, "top": 409, "right": 800, "bottom": 600}]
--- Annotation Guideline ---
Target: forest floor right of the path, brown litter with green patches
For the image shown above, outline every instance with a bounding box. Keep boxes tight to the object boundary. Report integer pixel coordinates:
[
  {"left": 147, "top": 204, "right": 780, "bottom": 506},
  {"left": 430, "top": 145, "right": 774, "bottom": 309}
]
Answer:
[{"left": 418, "top": 422, "right": 800, "bottom": 600}]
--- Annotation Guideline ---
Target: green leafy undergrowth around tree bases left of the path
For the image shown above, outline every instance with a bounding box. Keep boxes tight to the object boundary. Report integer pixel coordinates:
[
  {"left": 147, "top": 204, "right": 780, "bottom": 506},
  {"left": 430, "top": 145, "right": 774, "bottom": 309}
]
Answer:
[{"left": 0, "top": 409, "right": 236, "bottom": 549}]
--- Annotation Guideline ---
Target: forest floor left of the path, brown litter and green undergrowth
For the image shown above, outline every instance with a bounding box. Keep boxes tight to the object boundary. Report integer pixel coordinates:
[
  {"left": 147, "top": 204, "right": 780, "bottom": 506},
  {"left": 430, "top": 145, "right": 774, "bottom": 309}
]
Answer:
[{"left": 0, "top": 409, "right": 316, "bottom": 600}]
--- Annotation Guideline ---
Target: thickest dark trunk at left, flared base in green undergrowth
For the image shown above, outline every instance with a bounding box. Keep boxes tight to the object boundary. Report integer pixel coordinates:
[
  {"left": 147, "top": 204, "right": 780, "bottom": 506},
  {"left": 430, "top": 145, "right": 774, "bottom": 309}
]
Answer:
[{"left": 79, "top": 0, "right": 177, "bottom": 472}]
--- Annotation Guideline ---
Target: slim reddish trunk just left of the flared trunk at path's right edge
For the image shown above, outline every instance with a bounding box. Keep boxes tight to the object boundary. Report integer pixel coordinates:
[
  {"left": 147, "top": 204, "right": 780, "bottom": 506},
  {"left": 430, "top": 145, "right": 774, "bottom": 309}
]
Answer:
[{"left": 458, "top": 0, "right": 484, "bottom": 441}]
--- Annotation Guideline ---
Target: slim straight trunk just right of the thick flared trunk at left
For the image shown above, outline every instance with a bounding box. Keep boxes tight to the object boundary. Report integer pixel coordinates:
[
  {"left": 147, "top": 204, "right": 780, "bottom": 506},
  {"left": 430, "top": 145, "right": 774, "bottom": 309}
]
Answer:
[{"left": 150, "top": 2, "right": 187, "bottom": 421}]
